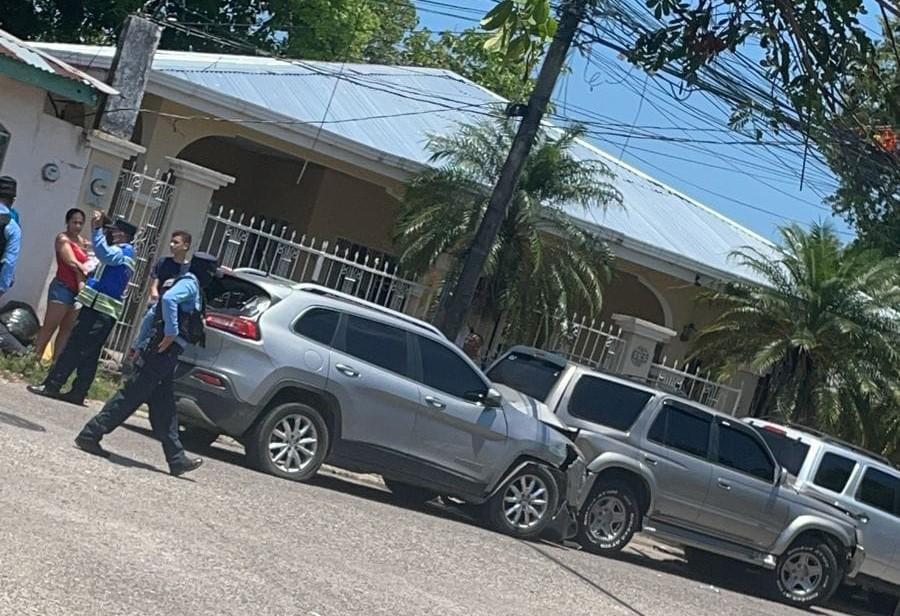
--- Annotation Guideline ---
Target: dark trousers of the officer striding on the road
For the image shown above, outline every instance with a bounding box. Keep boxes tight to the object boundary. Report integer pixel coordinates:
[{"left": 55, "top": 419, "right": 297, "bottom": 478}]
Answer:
[{"left": 79, "top": 343, "right": 187, "bottom": 465}]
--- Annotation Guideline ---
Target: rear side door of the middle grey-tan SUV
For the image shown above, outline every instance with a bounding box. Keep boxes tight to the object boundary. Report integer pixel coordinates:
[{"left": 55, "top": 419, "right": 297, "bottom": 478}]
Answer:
[{"left": 641, "top": 400, "right": 712, "bottom": 527}]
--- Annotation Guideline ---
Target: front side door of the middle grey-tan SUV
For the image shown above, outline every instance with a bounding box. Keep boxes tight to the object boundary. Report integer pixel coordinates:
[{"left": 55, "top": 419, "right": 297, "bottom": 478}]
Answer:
[{"left": 700, "top": 419, "right": 790, "bottom": 549}]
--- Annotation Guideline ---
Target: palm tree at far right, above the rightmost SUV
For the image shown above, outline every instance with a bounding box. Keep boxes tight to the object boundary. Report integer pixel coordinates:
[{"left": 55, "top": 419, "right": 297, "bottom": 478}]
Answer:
[{"left": 693, "top": 224, "right": 900, "bottom": 425}]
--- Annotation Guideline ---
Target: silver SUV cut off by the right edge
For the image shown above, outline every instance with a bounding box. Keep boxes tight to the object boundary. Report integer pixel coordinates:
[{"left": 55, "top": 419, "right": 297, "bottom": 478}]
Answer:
[{"left": 744, "top": 418, "right": 900, "bottom": 596}]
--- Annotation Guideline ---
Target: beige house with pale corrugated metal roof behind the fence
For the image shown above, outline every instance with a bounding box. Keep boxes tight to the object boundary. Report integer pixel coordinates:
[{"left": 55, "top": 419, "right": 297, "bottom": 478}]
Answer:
[{"left": 36, "top": 44, "right": 771, "bottom": 410}]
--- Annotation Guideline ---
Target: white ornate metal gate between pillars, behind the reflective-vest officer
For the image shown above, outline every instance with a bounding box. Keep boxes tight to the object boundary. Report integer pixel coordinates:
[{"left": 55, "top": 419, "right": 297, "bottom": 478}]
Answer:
[{"left": 104, "top": 167, "right": 175, "bottom": 363}]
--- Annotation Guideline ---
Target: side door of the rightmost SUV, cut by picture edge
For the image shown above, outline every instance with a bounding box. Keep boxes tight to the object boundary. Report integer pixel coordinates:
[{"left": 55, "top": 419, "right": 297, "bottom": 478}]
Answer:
[{"left": 855, "top": 466, "right": 900, "bottom": 584}]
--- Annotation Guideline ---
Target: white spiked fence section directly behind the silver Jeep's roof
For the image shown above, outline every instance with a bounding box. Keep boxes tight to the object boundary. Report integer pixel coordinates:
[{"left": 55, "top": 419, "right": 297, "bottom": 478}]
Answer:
[{"left": 200, "top": 206, "right": 435, "bottom": 318}]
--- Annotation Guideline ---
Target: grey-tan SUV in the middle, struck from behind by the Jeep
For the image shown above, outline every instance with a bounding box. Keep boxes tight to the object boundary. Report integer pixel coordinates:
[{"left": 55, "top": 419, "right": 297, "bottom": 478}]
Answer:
[{"left": 488, "top": 347, "right": 864, "bottom": 605}]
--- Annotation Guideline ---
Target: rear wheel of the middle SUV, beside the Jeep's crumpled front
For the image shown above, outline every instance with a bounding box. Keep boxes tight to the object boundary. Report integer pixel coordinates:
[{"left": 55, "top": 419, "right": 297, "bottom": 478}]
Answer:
[{"left": 576, "top": 482, "right": 641, "bottom": 555}]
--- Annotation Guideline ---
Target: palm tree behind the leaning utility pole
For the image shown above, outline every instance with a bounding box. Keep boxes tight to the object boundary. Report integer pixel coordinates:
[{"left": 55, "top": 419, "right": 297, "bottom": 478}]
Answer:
[{"left": 394, "top": 120, "right": 621, "bottom": 342}]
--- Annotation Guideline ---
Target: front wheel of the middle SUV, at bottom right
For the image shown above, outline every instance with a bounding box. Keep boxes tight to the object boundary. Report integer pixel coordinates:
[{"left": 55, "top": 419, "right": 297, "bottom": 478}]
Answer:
[{"left": 773, "top": 538, "right": 844, "bottom": 607}]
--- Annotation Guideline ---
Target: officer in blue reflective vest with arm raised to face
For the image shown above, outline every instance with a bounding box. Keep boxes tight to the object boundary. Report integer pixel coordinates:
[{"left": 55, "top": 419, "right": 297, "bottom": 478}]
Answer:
[{"left": 28, "top": 211, "right": 137, "bottom": 405}]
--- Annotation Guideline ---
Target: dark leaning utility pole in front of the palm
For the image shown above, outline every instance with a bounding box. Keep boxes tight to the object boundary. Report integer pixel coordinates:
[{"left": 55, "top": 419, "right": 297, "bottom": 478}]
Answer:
[{"left": 435, "top": 0, "right": 590, "bottom": 340}]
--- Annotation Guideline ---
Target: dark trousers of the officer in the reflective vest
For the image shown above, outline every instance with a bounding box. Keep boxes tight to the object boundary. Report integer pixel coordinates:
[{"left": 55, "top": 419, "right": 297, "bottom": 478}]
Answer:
[{"left": 44, "top": 306, "right": 116, "bottom": 398}]
